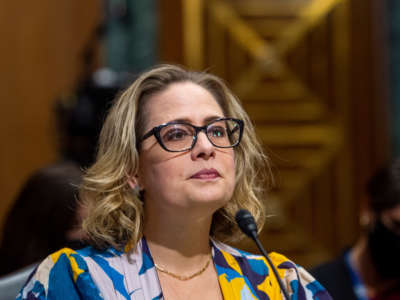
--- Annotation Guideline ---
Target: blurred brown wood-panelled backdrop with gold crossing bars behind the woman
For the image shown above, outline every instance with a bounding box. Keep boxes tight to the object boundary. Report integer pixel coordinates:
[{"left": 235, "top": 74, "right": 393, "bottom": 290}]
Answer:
[{"left": 0, "top": 0, "right": 400, "bottom": 267}]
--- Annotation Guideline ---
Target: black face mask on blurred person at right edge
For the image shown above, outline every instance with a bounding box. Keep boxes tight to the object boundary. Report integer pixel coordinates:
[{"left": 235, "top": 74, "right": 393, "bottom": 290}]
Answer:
[{"left": 368, "top": 220, "right": 400, "bottom": 279}]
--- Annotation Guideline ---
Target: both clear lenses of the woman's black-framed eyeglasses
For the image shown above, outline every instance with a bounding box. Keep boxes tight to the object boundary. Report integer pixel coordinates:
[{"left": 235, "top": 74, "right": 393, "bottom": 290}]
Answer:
[{"left": 160, "top": 120, "right": 240, "bottom": 151}]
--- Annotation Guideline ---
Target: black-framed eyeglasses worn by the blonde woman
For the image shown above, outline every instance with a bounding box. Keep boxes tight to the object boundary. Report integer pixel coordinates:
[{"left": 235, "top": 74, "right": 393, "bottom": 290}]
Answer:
[{"left": 138, "top": 118, "right": 244, "bottom": 152}]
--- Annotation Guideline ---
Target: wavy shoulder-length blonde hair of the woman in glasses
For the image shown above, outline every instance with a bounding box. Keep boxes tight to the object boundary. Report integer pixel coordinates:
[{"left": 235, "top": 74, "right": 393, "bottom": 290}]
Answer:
[{"left": 80, "top": 65, "right": 270, "bottom": 250}]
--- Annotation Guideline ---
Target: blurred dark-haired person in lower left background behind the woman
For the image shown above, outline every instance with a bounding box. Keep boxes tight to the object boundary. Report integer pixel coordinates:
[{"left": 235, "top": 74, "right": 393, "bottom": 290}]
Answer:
[{"left": 0, "top": 162, "right": 83, "bottom": 275}]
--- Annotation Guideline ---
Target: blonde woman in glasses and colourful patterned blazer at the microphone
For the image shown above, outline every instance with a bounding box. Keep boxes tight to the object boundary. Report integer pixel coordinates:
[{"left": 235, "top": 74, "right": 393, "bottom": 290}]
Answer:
[{"left": 19, "top": 65, "right": 330, "bottom": 300}]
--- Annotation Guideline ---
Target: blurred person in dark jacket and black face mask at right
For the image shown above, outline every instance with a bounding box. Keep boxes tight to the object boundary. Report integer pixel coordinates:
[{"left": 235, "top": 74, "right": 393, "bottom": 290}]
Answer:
[{"left": 311, "top": 159, "right": 400, "bottom": 300}]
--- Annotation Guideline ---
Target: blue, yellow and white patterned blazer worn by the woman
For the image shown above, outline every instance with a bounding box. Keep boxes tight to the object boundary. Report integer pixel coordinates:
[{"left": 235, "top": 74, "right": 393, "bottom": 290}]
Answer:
[{"left": 17, "top": 238, "right": 331, "bottom": 300}]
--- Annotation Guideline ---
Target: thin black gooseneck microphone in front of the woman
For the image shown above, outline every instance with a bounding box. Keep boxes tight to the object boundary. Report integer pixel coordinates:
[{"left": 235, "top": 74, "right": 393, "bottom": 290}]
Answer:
[{"left": 235, "top": 209, "right": 290, "bottom": 300}]
